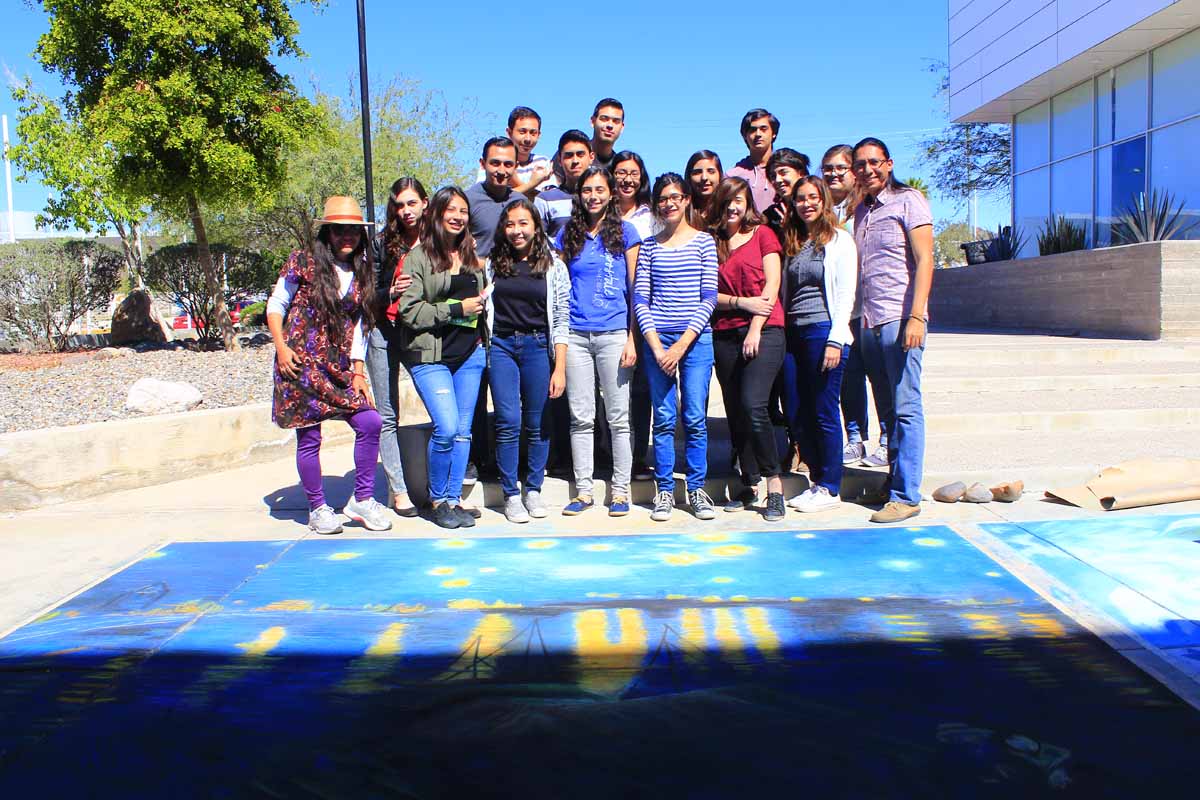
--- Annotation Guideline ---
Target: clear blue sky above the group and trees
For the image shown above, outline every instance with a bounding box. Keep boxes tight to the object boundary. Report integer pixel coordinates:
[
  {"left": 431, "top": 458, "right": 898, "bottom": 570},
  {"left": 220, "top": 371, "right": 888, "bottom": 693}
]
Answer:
[{"left": 0, "top": 0, "right": 1008, "bottom": 228}]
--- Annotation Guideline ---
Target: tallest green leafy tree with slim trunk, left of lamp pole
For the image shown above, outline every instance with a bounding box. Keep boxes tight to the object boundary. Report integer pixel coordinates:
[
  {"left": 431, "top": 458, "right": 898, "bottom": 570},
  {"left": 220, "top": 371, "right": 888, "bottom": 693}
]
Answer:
[{"left": 36, "top": 0, "right": 323, "bottom": 349}]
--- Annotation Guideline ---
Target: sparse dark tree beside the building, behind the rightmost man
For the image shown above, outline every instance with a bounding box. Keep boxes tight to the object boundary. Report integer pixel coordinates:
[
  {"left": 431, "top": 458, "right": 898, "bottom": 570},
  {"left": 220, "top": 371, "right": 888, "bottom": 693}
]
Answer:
[{"left": 918, "top": 62, "right": 1013, "bottom": 206}]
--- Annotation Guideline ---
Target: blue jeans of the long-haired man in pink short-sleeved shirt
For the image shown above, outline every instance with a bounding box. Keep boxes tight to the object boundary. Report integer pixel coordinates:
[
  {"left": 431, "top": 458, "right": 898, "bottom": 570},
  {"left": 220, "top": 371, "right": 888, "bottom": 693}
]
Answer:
[{"left": 863, "top": 319, "right": 925, "bottom": 505}]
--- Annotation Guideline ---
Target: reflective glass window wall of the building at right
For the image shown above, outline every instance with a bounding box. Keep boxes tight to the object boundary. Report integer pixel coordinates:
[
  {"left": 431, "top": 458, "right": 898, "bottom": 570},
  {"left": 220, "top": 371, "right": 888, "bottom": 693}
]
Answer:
[{"left": 1013, "top": 29, "right": 1200, "bottom": 255}]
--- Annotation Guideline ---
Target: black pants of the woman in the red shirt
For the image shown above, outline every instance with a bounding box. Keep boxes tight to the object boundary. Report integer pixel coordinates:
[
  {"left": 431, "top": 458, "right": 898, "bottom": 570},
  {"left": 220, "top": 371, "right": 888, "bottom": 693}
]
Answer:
[{"left": 713, "top": 327, "right": 786, "bottom": 487}]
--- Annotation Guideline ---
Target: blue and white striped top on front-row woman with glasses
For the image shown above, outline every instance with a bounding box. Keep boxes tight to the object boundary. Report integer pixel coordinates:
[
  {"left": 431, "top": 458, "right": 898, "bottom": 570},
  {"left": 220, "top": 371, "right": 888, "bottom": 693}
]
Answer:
[{"left": 634, "top": 233, "right": 718, "bottom": 335}]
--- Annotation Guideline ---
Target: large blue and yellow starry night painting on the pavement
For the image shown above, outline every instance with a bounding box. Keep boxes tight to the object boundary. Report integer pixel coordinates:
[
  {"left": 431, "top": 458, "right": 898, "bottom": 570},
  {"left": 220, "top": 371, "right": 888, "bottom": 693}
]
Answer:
[{"left": 0, "top": 527, "right": 1200, "bottom": 798}]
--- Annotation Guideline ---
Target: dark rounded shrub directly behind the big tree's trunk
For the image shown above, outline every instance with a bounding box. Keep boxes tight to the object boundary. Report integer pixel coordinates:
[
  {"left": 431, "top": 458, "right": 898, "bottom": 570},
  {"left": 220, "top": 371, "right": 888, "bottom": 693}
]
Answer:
[{"left": 145, "top": 243, "right": 274, "bottom": 343}]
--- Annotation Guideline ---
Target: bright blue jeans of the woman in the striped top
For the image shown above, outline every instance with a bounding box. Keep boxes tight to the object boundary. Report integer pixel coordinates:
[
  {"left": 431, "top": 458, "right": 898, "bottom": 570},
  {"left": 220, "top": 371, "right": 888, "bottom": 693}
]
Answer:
[{"left": 642, "top": 331, "right": 713, "bottom": 494}]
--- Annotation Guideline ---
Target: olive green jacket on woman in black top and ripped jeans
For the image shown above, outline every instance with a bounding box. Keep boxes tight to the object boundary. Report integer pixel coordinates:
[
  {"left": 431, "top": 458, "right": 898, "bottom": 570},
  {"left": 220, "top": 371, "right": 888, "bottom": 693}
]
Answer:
[{"left": 397, "top": 245, "right": 488, "bottom": 363}]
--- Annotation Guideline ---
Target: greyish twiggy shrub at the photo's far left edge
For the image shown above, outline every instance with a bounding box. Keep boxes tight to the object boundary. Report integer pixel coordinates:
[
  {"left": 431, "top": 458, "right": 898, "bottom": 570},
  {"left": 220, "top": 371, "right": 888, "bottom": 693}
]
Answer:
[{"left": 0, "top": 239, "right": 125, "bottom": 350}]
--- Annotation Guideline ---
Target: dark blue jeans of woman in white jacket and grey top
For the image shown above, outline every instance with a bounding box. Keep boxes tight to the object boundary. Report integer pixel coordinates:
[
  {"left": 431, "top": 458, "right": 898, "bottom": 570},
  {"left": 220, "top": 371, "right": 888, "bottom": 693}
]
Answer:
[{"left": 784, "top": 323, "right": 850, "bottom": 497}]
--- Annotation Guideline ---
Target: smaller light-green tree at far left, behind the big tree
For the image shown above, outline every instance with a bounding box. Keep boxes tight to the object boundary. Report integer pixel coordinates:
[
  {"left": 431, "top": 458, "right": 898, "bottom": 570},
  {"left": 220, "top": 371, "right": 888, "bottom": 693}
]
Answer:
[{"left": 10, "top": 79, "right": 145, "bottom": 287}]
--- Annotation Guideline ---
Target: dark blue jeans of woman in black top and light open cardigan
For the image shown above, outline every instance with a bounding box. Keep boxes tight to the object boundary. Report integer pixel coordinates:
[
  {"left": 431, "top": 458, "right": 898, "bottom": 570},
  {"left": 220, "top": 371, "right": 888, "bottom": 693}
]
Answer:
[{"left": 487, "top": 333, "right": 550, "bottom": 498}]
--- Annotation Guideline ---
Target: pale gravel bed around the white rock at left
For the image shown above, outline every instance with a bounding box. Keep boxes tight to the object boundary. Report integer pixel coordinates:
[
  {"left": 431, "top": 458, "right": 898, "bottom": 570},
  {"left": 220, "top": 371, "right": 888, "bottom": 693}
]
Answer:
[{"left": 0, "top": 344, "right": 275, "bottom": 433}]
